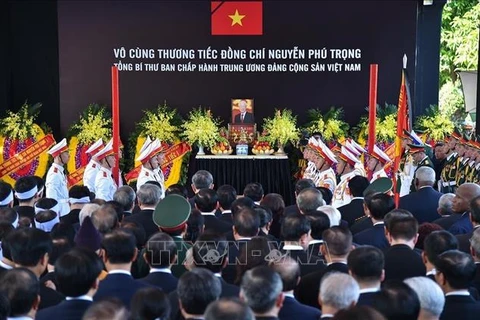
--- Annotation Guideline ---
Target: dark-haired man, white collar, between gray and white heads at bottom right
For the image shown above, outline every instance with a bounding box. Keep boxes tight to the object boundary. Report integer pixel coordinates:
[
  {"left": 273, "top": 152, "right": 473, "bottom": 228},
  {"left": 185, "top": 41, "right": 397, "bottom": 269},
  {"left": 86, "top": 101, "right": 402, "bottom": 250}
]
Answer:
[{"left": 347, "top": 246, "right": 385, "bottom": 306}]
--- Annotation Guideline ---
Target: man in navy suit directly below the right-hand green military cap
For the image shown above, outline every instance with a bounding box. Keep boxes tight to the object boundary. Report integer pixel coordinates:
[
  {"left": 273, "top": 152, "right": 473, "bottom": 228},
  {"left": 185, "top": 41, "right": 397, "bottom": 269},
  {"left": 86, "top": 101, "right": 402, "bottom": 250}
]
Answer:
[{"left": 353, "top": 193, "right": 395, "bottom": 249}]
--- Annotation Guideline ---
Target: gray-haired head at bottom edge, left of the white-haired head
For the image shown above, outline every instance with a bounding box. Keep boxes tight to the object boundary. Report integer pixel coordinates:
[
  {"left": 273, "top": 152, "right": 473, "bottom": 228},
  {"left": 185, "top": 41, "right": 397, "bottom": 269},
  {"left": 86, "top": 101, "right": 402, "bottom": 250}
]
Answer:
[{"left": 318, "top": 272, "right": 360, "bottom": 319}]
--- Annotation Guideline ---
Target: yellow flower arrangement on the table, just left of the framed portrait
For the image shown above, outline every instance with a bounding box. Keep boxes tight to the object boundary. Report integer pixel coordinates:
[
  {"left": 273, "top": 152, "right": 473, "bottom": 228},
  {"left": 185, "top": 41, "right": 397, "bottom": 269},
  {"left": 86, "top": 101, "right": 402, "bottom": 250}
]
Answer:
[{"left": 181, "top": 107, "right": 221, "bottom": 155}]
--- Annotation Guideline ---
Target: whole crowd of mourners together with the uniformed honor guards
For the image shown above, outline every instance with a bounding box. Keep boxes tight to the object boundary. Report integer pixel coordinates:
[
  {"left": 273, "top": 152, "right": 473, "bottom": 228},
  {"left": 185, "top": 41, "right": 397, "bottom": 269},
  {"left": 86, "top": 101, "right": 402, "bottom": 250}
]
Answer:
[{"left": 0, "top": 132, "right": 480, "bottom": 320}]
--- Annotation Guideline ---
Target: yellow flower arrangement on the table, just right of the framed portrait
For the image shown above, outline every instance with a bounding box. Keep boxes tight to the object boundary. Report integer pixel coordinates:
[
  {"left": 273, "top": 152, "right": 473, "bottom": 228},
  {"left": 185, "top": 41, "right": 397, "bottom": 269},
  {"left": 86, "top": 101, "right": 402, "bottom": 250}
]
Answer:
[{"left": 263, "top": 109, "right": 300, "bottom": 154}]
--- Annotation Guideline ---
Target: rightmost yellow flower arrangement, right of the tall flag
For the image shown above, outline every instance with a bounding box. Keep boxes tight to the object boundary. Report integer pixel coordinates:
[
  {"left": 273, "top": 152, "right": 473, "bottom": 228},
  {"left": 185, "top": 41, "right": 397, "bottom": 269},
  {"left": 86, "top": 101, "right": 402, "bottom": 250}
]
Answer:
[{"left": 415, "top": 105, "right": 454, "bottom": 143}]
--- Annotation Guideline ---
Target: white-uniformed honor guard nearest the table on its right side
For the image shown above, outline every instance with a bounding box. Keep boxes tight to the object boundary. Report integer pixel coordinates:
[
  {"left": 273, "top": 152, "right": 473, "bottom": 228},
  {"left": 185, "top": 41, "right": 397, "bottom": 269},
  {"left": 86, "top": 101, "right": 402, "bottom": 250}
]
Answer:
[{"left": 312, "top": 137, "right": 338, "bottom": 194}]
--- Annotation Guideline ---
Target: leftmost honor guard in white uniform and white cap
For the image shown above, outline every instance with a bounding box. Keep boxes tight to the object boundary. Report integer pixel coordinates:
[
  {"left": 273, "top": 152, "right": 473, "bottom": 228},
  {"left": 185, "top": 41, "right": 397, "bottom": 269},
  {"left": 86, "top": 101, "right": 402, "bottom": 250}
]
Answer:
[{"left": 45, "top": 138, "right": 70, "bottom": 216}]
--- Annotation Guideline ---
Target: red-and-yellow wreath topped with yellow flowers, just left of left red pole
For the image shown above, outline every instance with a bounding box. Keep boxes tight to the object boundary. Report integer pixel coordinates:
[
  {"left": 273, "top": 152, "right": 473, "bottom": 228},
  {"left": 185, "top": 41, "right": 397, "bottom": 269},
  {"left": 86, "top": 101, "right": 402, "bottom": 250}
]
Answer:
[{"left": 67, "top": 103, "right": 112, "bottom": 186}]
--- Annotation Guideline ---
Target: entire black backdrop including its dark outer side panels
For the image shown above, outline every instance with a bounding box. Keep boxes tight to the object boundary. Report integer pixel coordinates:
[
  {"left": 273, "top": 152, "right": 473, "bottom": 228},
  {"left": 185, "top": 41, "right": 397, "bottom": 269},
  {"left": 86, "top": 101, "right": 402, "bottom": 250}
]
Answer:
[{"left": 0, "top": 0, "right": 445, "bottom": 143}]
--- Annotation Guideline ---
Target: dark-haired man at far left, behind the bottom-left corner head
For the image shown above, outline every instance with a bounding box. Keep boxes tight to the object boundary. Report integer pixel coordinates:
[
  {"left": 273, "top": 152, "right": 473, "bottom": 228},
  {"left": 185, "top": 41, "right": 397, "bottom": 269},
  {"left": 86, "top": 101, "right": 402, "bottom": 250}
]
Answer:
[{"left": 8, "top": 229, "right": 64, "bottom": 309}]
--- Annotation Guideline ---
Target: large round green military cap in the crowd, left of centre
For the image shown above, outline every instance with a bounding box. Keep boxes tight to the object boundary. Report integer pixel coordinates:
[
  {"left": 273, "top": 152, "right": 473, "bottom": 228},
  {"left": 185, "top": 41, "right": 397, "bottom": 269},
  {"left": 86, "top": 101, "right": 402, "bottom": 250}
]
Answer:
[{"left": 153, "top": 194, "right": 191, "bottom": 232}]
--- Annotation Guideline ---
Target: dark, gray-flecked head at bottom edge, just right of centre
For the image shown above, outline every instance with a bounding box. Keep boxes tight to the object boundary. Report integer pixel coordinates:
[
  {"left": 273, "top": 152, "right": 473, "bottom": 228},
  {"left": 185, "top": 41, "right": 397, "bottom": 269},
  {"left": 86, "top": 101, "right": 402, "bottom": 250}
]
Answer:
[{"left": 240, "top": 266, "right": 284, "bottom": 320}]
